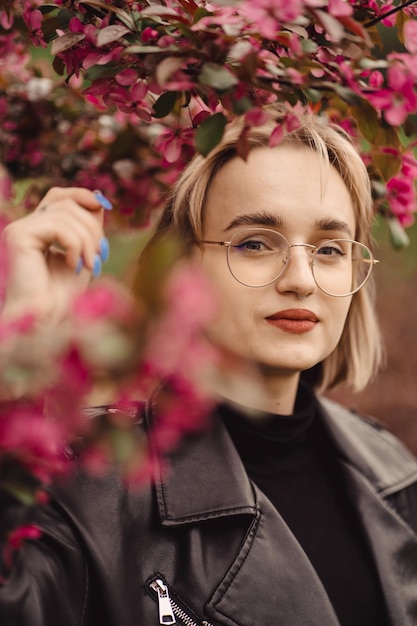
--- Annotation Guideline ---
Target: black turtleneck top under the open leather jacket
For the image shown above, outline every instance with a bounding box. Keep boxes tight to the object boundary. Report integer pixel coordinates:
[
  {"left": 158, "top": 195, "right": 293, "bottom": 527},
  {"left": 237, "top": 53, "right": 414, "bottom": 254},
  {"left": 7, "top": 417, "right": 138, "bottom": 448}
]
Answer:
[{"left": 220, "top": 388, "right": 387, "bottom": 626}]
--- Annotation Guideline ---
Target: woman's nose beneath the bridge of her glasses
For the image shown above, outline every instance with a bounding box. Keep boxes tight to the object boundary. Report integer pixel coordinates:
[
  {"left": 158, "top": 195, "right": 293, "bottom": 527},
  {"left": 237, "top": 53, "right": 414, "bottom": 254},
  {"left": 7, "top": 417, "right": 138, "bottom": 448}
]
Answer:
[{"left": 276, "top": 245, "right": 317, "bottom": 295}]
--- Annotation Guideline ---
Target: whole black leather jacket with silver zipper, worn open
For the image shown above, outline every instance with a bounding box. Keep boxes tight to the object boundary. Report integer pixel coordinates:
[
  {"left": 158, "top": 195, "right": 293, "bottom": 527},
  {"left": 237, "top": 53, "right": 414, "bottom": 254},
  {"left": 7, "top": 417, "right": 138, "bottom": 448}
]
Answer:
[{"left": 0, "top": 400, "right": 417, "bottom": 626}]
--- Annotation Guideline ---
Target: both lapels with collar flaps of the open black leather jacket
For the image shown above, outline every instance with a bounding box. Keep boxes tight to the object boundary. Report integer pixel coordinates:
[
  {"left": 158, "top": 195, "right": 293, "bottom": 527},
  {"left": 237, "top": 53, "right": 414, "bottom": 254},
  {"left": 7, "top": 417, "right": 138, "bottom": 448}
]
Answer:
[{"left": 147, "top": 400, "right": 417, "bottom": 626}]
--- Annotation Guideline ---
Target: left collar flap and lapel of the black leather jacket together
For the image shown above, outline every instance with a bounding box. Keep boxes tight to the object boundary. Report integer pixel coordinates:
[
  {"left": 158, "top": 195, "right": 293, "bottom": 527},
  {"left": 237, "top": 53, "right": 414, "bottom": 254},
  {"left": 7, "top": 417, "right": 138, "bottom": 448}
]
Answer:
[{"left": 148, "top": 400, "right": 339, "bottom": 626}]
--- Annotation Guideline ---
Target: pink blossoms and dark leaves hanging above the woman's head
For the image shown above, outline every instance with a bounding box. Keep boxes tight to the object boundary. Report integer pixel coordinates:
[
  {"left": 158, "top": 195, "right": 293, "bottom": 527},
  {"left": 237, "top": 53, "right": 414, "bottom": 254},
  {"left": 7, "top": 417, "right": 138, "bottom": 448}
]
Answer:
[{"left": 0, "top": 0, "right": 417, "bottom": 234}]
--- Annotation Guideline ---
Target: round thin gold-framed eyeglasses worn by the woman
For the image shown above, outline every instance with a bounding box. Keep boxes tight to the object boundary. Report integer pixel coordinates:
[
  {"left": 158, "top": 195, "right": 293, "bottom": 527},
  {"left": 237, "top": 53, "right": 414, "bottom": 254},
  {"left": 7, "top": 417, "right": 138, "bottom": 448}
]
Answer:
[{"left": 199, "top": 228, "right": 379, "bottom": 298}]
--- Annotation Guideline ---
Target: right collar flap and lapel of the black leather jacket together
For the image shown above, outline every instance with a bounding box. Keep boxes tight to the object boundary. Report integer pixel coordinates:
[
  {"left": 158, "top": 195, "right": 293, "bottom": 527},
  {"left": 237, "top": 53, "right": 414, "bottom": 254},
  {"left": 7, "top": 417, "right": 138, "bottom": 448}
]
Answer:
[{"left": 322, "top": 400, "right": 417, "bottom": 626}]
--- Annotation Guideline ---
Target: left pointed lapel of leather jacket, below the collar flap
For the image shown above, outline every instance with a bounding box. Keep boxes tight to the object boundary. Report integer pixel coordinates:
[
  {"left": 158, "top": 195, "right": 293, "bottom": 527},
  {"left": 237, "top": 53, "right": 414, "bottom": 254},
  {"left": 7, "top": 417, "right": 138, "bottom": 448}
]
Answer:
[{"left": 206, "top": 487, "right": 339, "bottom": 626}]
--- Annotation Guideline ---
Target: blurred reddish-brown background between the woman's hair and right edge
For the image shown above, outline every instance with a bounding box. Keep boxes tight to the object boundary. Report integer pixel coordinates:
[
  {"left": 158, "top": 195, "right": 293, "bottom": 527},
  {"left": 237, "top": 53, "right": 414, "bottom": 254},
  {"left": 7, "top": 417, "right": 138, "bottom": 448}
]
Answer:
[{"left": 329, "top": 222, "right": 417, "bottom": 455}]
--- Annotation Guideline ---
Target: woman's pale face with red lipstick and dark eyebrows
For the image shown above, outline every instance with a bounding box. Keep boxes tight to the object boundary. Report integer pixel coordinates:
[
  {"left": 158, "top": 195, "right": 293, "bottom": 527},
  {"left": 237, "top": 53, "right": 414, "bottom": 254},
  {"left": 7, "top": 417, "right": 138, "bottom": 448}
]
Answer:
[{"left": 198, "top": 146, "right": 355, "bottom": 376}]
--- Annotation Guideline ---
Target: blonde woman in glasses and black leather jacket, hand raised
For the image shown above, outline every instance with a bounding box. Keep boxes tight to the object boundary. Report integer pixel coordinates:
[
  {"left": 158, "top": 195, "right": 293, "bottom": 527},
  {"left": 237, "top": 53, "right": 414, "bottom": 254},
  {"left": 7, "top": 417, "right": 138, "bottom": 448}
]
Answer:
[{"left": 0, "top": 112, "right": 417, "bottom": 626}]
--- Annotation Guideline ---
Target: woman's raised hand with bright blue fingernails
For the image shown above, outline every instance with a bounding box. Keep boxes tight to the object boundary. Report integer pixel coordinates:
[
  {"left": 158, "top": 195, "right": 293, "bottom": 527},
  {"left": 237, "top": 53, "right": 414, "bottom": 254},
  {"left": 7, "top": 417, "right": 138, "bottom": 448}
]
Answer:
[{"left": 2, "top": 187, "right": 111, "bottom": 323}]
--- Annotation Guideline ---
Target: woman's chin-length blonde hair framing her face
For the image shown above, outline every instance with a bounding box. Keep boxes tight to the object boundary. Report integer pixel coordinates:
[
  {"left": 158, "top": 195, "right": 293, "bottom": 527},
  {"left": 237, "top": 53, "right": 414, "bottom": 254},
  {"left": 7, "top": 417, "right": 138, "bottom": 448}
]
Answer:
[{"left": 139, "top": 110, "right": 382, "bottom": 391}]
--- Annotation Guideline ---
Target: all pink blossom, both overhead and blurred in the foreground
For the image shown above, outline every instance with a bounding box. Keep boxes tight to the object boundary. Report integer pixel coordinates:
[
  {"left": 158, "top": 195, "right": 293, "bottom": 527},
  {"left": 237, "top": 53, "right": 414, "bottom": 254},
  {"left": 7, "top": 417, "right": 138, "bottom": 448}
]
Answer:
[{"left": 0, "top": 0, "right": 417, "bottom": 560}]
